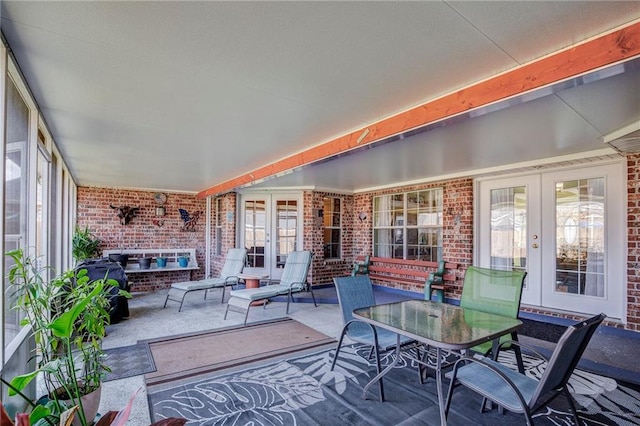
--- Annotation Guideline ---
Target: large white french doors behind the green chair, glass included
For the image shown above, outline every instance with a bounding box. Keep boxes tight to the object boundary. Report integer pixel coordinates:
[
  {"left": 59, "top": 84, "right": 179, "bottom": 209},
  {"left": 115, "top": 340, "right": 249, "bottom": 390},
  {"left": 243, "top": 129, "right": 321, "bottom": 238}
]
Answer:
[{"left": 476, "top": 163, "right": 626, "bottom": 318}]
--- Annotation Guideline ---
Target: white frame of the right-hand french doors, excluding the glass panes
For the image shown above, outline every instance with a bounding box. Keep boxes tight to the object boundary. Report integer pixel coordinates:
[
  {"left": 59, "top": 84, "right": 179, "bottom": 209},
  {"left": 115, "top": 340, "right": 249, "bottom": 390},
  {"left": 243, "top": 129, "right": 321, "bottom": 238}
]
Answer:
[{"left": 473, "top": 161, "right": 627, "bottom": 322}]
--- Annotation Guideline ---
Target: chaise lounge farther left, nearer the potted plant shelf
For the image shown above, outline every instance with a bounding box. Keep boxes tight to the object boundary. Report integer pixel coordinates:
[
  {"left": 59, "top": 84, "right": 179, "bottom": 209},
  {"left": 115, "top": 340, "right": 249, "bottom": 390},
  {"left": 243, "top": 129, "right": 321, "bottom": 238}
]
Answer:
[{"left": 163, "top": 248, "right": 247, "bottom": 312}]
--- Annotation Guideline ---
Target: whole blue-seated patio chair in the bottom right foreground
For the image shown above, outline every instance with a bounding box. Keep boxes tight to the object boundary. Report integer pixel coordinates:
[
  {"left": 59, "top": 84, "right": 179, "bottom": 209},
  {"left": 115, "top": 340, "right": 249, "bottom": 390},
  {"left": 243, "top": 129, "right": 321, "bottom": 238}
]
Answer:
[{"left": 445, "top": 314, "right": 606, "bottom": 425}]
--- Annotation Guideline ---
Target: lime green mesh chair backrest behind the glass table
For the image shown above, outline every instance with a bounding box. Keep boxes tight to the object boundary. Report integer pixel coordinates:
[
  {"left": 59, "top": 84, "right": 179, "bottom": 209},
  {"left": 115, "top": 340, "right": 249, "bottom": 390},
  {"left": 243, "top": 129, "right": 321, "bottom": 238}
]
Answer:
[{"left": 460, "top": 266, "right": 527, "bottom": 318}]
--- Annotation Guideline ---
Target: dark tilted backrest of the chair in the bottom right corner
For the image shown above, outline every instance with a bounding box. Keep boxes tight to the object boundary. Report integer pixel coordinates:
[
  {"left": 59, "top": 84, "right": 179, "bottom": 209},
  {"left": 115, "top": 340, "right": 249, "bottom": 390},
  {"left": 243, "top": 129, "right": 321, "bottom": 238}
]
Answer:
[{"left": 528, "top": 314, "right": 607, "bottom": 407}]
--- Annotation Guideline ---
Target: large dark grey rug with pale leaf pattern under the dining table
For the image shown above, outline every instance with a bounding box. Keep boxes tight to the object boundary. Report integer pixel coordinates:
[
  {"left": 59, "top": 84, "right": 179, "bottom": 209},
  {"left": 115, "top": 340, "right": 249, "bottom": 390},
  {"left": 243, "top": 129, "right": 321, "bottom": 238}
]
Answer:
[{"left": 148, "top": 345, "right": 640, "bottom": 426}]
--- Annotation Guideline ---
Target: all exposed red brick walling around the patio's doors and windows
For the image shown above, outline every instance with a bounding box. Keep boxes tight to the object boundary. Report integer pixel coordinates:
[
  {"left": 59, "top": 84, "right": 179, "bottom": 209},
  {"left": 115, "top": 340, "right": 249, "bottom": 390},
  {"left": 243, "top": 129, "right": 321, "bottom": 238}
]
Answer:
[{"left": 78, "top": 161, "right": 640, "bottom": 331}]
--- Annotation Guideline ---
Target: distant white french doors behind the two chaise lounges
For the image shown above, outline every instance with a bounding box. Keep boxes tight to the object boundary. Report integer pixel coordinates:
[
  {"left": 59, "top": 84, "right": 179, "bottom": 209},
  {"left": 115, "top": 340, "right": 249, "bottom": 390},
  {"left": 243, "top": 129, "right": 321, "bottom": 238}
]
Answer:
[{"left": 239, "top": 193, "right": 302, "bottom": 279}]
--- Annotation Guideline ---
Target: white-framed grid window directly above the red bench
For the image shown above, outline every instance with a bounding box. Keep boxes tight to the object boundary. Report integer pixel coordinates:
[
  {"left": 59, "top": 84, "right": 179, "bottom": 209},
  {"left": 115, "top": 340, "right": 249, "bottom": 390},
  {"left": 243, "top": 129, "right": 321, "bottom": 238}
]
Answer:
[{"left": 373, "top": 188, "right": 442, "bottom": 262}]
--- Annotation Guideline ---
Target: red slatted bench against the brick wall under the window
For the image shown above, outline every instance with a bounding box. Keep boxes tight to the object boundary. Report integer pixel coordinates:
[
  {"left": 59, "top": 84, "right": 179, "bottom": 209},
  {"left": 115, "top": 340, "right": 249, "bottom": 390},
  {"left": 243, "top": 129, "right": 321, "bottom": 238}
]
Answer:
[{"left": 354, "top": 256, "right": 458, "bottom": 302}]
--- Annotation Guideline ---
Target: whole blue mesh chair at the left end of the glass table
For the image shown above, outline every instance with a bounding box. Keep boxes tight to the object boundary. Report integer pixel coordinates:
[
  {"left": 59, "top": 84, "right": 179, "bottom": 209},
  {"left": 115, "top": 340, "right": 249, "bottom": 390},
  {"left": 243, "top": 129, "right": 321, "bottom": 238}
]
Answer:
[{"left": 331, "top": 275, "right": 415, "bottom": 402}]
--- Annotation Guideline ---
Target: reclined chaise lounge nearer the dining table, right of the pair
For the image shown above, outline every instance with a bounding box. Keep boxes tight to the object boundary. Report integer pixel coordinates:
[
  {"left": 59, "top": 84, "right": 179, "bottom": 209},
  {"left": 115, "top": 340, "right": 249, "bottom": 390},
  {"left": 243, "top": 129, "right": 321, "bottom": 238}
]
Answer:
[{"left": 224, "top": 250, "right": 318, "bottom": 325}]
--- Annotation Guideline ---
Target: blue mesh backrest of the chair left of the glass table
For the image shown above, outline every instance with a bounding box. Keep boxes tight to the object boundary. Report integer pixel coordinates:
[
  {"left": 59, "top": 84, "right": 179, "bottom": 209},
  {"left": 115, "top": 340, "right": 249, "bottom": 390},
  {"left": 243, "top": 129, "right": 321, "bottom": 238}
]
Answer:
[{"left": 333, "top": 275, "right": 376, "bottom": 334}]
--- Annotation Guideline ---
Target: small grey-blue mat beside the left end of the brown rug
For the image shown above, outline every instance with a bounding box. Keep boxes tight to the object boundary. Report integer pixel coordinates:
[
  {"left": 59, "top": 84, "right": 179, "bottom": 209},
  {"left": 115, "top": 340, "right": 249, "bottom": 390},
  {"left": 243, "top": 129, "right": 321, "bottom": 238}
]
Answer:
[{"left": 104, "top": 343, "right": 156, "bottom": 382}]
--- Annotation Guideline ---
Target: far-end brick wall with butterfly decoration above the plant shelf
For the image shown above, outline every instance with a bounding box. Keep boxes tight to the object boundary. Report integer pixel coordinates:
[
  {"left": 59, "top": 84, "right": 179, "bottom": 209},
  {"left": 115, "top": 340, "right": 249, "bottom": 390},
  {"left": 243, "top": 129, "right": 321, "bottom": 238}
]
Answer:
[{"left": 77, "top": 187, "right": 206, "bottom": 291}]
